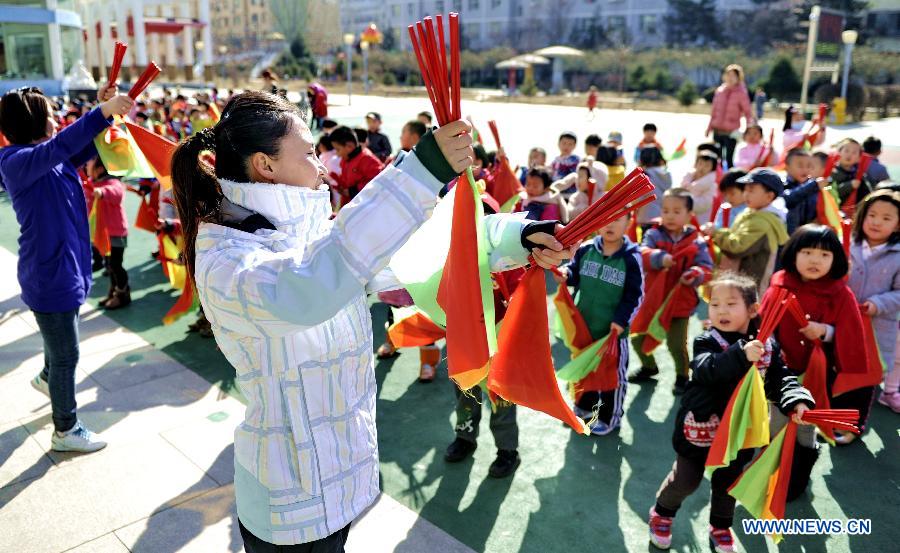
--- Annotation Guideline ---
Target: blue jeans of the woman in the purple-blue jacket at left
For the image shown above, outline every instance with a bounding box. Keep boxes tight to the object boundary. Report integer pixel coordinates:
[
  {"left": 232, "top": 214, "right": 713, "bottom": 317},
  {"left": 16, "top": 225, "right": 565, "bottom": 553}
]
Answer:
[{"left": 34, "top": 309, "right": 78, "bottom": 432}]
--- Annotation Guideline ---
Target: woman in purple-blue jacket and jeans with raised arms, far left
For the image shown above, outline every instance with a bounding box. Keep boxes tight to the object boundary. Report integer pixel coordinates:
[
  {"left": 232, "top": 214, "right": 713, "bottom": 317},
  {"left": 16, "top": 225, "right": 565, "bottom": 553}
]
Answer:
[{"left": 0, "top": 86, "right": 134, "bottom": 452}]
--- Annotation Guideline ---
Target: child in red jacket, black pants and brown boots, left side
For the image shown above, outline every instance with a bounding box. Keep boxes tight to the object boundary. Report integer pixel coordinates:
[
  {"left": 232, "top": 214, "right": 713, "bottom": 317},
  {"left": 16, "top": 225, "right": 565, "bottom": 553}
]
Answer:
[{"left": 86, "top": 157, "right": 131, "bottom": 309}]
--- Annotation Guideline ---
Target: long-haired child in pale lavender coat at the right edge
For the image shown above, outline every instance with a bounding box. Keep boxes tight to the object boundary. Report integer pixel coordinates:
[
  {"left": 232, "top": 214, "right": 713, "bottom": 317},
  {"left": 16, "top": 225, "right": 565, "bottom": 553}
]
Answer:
[{"left": 847, "top": 190, "right": 900, "bottom": 413}]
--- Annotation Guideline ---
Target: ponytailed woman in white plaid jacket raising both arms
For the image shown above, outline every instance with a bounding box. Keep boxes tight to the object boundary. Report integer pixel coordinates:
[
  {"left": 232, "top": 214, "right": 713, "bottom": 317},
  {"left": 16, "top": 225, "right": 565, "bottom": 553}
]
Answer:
[{"left": 172, "top": 92, "right": 571, "bottom": 553}]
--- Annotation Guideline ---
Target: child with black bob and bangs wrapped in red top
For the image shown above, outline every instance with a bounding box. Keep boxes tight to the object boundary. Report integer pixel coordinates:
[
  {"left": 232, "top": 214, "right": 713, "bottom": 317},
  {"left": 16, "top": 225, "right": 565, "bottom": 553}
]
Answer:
[{"left": 762, "top": 225, "right": 874, "bottom": 444}]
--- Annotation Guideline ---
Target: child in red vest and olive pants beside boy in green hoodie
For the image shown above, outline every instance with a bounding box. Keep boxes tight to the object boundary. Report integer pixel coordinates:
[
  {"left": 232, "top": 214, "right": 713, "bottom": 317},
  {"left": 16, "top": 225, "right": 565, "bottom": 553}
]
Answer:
[{"left": 628, "top": 188, "right": 713, "bottom": 394}]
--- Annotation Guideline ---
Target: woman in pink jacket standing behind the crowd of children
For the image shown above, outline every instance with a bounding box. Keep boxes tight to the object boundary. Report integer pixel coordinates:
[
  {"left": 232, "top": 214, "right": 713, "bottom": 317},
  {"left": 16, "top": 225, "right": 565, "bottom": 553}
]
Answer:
[{"left": 706, "top": 64, "right": 755, "bottom": 169}]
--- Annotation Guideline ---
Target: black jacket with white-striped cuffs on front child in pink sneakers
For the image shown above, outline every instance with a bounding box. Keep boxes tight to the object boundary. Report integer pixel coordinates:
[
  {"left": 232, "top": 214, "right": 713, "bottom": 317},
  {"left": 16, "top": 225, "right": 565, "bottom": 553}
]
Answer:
[{"left": 672, "top": 328, "right": 815, "bottom": 459}]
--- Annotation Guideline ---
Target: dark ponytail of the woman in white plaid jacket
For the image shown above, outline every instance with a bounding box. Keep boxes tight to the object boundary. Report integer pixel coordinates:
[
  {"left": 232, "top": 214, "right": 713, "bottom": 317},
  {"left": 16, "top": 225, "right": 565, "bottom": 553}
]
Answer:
[{"left": 172, "top": 129, "right": 222, "bottom": 280}]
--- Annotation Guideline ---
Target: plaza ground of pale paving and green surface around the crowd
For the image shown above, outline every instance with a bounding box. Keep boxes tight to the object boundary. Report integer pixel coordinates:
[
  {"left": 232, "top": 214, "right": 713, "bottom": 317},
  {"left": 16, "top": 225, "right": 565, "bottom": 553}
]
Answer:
[{"left": 0, "top": 95, "right": 900, "bottom": 553}]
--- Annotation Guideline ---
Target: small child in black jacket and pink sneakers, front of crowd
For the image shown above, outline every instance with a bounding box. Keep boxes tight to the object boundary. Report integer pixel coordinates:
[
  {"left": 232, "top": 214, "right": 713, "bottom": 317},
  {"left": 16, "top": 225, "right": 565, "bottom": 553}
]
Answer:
[{"left": 649, "top": 272, "right": 815, "bottom": 553}]
